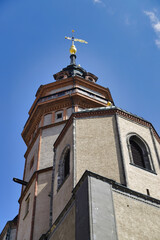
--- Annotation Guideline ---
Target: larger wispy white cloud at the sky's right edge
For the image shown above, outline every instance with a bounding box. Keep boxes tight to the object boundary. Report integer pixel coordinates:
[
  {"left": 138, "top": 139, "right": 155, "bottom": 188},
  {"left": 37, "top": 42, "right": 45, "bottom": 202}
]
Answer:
[{"left": 144, "top": 10, "right": 160, "bottom": 48}]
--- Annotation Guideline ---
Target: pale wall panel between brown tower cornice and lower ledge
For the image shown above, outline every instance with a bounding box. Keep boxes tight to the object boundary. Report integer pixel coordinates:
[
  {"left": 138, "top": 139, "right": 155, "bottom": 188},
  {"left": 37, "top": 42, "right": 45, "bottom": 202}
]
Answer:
[{"left": 39, "top": 124, "right": 64, "bottom": 169}]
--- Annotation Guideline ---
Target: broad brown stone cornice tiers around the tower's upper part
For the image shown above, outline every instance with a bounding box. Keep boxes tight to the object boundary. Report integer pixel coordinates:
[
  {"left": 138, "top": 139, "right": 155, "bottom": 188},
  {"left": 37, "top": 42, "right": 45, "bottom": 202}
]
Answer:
[{"left": 22, "top": 76, "right": 114, "bottom": 146}]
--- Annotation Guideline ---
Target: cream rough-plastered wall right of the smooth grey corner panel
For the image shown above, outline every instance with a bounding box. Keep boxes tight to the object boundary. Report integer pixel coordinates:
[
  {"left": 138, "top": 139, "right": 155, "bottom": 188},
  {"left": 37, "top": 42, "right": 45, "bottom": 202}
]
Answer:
[{"left": 113, "top": 191, "right": 160, "bottom": 240}]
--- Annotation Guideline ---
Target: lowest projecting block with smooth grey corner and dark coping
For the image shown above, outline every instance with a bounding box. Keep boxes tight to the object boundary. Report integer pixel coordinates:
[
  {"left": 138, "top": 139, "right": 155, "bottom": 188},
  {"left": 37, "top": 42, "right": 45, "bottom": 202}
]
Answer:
[{"left": 47, "top": 172, "right": 160, "bottom": 240}]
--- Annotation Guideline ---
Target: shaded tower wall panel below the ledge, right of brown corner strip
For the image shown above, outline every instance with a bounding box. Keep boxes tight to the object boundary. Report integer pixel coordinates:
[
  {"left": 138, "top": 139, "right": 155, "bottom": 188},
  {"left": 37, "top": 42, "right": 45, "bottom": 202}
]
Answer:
[{"left": 33, "top": 171, "right": 52, "bottom": 240}]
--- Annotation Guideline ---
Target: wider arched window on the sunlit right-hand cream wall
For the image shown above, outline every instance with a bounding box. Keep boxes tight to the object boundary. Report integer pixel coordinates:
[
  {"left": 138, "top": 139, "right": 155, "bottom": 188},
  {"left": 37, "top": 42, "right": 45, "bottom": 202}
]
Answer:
[{"left": 129, "top": 135, "right": 152, "bottom": 170}]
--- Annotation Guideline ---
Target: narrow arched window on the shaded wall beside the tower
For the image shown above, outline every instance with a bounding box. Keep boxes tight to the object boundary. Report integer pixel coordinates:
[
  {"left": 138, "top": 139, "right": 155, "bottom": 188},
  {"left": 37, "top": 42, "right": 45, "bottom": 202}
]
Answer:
[{"left": 57, "top": 145, "right": 70, "bottom": 189}]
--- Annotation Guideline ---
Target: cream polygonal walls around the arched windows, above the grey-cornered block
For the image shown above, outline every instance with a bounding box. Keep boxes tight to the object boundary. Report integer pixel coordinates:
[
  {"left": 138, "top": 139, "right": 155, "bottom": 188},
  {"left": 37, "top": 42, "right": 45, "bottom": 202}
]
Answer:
[{"left": 53, "top": 109, "right": 160, "bottom": 219}]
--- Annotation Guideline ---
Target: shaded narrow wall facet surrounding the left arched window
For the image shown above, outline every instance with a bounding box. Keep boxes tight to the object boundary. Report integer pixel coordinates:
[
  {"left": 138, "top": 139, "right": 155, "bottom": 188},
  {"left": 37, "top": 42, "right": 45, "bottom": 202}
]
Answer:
[{"left": 52, "top": 125, "right": 73, "bottom": 223}]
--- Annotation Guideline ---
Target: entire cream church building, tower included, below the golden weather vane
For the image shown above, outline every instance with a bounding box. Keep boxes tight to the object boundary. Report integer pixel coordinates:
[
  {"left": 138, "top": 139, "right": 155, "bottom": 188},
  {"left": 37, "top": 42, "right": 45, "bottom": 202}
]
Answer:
[{"left": 0, "top": 46, "right": 160, "bottom": 240}]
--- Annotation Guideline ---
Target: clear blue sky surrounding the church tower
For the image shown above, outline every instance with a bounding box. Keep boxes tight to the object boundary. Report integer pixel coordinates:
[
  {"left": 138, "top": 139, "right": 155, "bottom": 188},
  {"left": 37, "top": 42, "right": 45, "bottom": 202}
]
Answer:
[{"left": 0, "top": 0, "right": 160, "bottom": 231}]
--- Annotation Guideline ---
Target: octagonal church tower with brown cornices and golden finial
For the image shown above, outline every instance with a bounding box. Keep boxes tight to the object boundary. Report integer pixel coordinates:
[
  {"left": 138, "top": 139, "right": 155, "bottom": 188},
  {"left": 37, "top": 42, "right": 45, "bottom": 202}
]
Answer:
[{"left": 17, "top": 31, "right": 114, "bottom": 240}]
